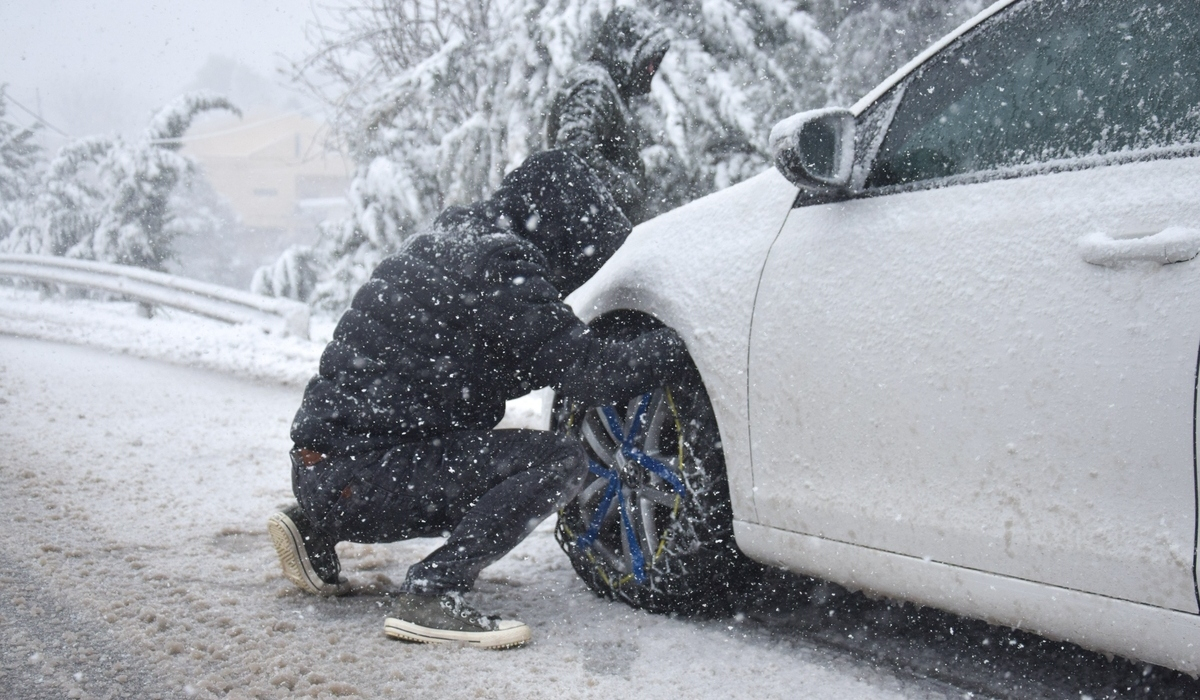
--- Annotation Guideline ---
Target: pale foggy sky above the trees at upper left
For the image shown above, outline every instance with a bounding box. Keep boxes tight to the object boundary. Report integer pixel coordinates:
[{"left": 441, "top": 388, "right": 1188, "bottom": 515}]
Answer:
[{"left": 0, "top": 0, "right": 344, "bottom": 140}]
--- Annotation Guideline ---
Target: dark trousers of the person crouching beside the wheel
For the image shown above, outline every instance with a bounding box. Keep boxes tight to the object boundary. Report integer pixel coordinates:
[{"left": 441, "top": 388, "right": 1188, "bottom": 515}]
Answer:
[{"left": 292, "top": 430, "right": 588, "bottom": 596}]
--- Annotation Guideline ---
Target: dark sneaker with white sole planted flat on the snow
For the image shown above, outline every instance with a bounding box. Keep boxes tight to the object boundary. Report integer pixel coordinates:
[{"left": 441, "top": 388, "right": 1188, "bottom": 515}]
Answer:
[{"left": 383, "top": 593, "right": 529, "bottom": 648}]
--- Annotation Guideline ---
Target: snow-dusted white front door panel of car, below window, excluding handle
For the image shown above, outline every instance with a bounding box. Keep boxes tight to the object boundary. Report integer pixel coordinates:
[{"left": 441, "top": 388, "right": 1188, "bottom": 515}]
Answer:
[{"left": 750, "top": 158, "right": 1200, "bottom": 612}]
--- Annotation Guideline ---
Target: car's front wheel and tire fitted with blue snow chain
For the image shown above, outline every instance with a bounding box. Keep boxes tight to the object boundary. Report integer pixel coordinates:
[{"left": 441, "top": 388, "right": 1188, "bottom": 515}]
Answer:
[{"left": 554, "top": 316, "right": 761, "bottom": 615}]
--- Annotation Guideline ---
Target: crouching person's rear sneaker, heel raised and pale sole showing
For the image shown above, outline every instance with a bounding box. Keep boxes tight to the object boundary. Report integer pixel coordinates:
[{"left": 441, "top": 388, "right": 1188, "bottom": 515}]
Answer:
[{"left": 266, "top": 505, "right": 349, "bottom": 596}]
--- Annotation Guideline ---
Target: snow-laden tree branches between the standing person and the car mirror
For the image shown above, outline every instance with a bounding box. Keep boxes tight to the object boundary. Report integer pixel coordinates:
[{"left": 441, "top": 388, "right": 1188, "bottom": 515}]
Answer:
[{"left": 640, "top": 0, "right": 830, "bottom": 211}]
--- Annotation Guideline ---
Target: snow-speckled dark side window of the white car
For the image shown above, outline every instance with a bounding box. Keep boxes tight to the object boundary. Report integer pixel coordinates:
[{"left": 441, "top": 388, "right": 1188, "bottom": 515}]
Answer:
[{"left": 865, "top": 0, "right": 1200, "bottom": 189}]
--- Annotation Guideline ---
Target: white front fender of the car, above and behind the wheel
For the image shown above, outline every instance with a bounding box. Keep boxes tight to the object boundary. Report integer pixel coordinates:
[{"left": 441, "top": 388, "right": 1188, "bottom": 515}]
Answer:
[{"left": 568, "top": 169, "right": 797, "bottom": 520}]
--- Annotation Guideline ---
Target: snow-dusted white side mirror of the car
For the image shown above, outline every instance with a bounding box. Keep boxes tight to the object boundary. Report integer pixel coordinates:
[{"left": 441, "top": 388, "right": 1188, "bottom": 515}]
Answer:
[{"left": 770, "top": 107, "right": 854, "bottom": 191}]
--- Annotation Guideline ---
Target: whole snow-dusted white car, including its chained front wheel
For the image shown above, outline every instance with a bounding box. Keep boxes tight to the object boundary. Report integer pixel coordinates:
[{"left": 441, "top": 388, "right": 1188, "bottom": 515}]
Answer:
[{"left": 549, "top": 0, "right": 1200, "bottom": 674}]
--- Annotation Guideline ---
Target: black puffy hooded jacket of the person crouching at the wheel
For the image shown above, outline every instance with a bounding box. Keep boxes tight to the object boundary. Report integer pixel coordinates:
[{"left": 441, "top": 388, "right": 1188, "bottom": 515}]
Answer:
[{"left": 292, "top": 151, "right": 685, "bottom": 454}]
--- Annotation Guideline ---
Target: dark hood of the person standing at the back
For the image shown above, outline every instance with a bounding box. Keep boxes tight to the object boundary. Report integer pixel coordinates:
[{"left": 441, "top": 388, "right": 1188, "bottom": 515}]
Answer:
[{"left": 592, "top": 7, "right": 671, "bottom": 97}]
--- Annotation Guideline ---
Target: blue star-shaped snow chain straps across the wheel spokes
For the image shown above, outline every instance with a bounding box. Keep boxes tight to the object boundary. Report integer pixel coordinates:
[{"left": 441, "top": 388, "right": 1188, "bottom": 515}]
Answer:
[{"left": 576, "top": 394, "right": 686, "bottom": 584}]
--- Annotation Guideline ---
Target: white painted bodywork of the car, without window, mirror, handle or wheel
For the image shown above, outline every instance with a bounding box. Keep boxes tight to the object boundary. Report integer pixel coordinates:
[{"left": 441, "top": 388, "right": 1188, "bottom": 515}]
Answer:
[{"left": 570, "top": 0, "right": 1200, "bottom": 675}]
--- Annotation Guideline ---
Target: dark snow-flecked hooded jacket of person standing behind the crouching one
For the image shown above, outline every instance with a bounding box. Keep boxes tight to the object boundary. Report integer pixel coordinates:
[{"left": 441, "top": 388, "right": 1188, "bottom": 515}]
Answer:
[{"left": 546, "top": 7, "right": 671, "bottom": 223}]
